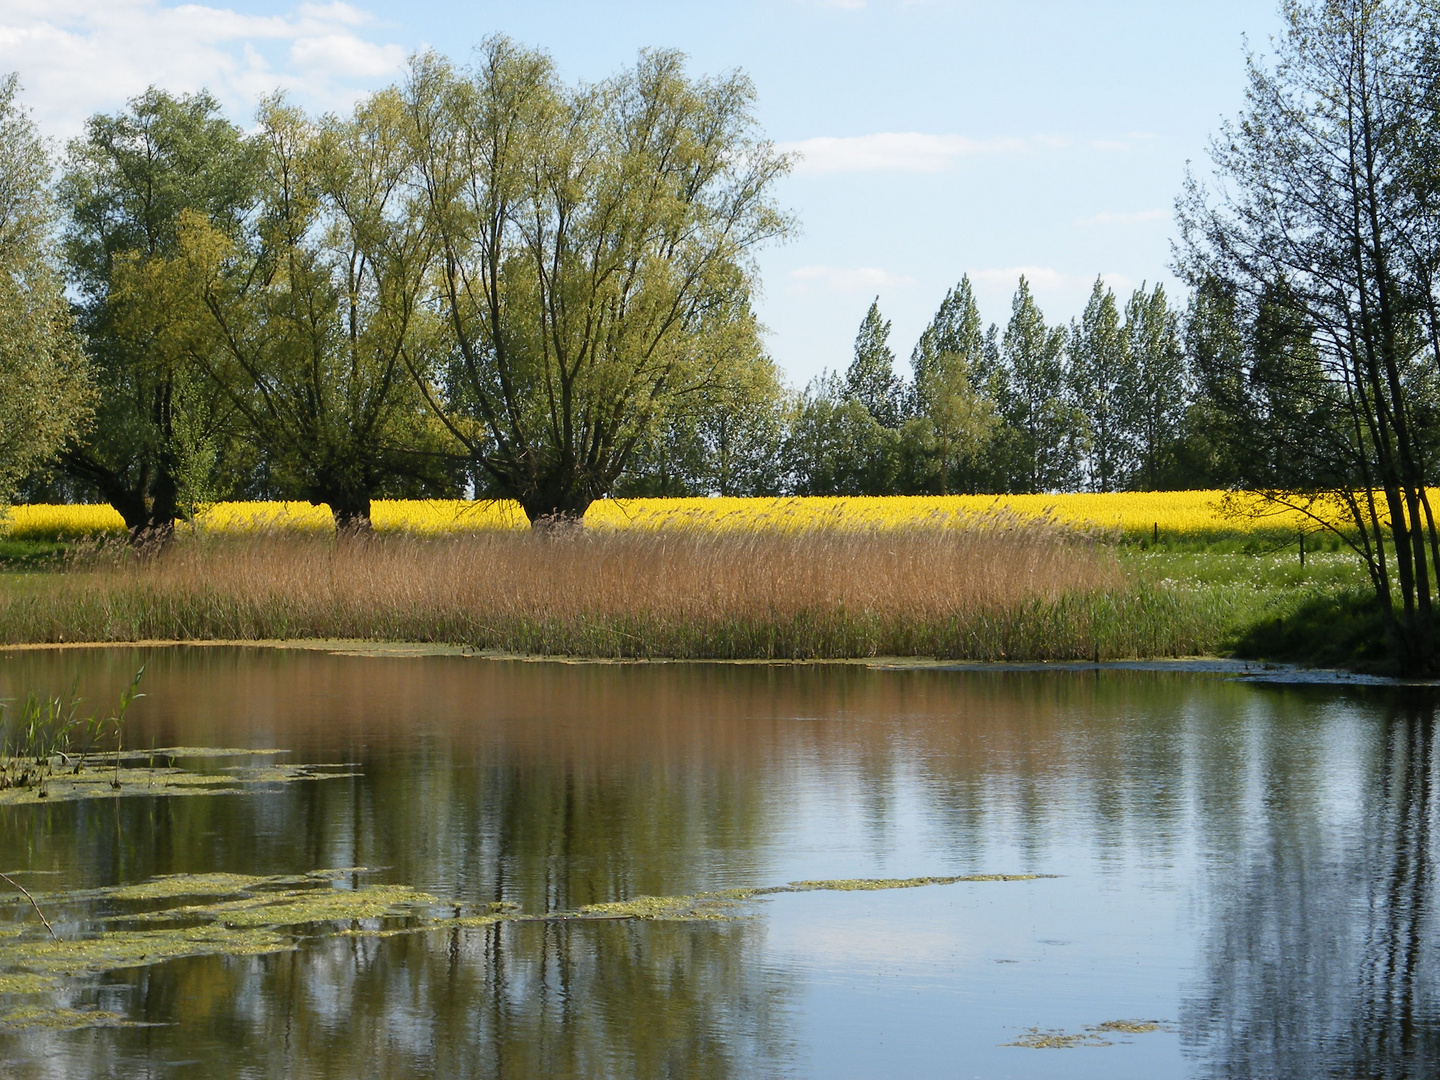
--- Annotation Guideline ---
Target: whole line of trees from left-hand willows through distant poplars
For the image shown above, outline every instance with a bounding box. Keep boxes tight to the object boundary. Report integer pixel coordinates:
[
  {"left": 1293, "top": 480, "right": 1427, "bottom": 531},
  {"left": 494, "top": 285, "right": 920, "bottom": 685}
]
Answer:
[{"left": 0, "top": 39, "right": 1319, "bottom": 536}]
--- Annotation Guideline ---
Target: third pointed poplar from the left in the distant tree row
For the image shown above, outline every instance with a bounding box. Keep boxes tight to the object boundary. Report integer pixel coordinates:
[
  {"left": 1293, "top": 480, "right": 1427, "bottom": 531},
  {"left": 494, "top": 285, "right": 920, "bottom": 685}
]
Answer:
[{"left": 996, "top": 276, "right": 1084, "bottom": 492}]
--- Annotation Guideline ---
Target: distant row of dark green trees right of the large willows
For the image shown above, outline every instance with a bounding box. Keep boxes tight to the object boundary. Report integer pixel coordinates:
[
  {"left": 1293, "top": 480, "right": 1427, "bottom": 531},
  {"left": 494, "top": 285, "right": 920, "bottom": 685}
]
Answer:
[{"left": 621, "top": 269, "right": 1342, "bottom": 495}]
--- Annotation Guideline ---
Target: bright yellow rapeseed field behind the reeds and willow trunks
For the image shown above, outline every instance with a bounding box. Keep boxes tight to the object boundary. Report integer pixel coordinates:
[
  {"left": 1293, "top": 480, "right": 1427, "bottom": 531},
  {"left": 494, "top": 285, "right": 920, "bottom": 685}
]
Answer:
[{"left": 0, "top": 491, "right": 1353, "bottom": 539}]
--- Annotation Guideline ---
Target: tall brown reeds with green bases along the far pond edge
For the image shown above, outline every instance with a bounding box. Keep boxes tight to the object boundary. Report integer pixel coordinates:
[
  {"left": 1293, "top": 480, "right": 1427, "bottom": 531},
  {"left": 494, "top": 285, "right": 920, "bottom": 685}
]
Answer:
[{"left": 0, "top": 516, "right": 1238, "bottom": 660}]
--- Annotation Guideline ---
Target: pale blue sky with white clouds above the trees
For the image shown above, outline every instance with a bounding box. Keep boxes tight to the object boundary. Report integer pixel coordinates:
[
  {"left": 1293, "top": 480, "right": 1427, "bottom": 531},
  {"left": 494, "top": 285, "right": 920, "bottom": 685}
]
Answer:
[{"left": 0, "top": 0, "right": 1279, "bottom": 387}]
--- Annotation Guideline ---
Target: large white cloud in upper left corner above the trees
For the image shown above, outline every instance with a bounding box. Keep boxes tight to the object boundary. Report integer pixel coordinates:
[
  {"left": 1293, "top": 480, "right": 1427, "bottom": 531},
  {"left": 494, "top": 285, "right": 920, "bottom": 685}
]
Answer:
[{"left": 0, "top": 0, "right": 405, "bottom": 135}]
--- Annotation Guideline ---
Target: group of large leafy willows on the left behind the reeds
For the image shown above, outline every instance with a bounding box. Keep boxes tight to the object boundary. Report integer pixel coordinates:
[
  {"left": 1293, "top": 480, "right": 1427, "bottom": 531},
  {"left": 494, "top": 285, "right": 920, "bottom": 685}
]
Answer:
[{"left": 0, "top": 37, "right": 791, "bottom": 536}]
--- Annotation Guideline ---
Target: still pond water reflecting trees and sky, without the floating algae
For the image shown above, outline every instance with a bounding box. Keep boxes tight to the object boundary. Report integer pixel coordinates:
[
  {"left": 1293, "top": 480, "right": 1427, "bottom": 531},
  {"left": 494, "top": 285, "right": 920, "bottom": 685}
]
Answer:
[{"left": 0, "top": 648, "right": 1440, "bottom": 1080}]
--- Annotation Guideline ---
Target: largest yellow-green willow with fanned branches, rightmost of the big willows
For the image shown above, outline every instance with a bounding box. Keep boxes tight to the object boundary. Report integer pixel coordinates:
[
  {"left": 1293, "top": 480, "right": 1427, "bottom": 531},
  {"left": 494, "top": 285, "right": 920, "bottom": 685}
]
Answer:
[{"left": 405, "top": 37, "right": 789, "bottom": 521}]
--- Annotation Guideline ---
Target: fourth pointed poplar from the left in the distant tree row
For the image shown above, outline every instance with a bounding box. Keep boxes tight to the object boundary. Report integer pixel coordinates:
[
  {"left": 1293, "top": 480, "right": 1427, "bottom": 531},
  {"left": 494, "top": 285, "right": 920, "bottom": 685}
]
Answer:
[{"left": 1070, "top": 278, "right": 1135, "bottom": 491}]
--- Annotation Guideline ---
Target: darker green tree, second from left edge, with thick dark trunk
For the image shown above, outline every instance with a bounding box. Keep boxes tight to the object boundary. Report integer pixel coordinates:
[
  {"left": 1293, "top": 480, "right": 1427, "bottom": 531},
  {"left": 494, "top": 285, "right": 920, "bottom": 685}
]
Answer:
[{"left": 60, "top": 88, "right": 255, "bottom": 537}]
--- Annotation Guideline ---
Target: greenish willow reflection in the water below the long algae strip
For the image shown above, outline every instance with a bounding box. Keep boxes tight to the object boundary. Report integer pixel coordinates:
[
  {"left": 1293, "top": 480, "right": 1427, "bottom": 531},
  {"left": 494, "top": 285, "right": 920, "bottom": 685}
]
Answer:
[{"left": 87, "top": 923, "right": 788, "bottom": 1080}]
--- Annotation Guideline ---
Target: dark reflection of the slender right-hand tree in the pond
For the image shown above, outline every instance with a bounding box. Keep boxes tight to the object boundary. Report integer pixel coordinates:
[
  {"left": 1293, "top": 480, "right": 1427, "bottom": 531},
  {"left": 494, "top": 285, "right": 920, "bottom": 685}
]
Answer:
[{"left": 1182, "top": 694, "right": 1440, "bottom": 1080}]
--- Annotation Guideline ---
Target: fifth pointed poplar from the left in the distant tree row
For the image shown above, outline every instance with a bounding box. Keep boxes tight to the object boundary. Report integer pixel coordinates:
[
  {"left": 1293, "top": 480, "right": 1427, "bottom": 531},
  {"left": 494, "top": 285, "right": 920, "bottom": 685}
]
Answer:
[{"left": 1122, "top": 285, "right": 1189, "bottom": 491}]
